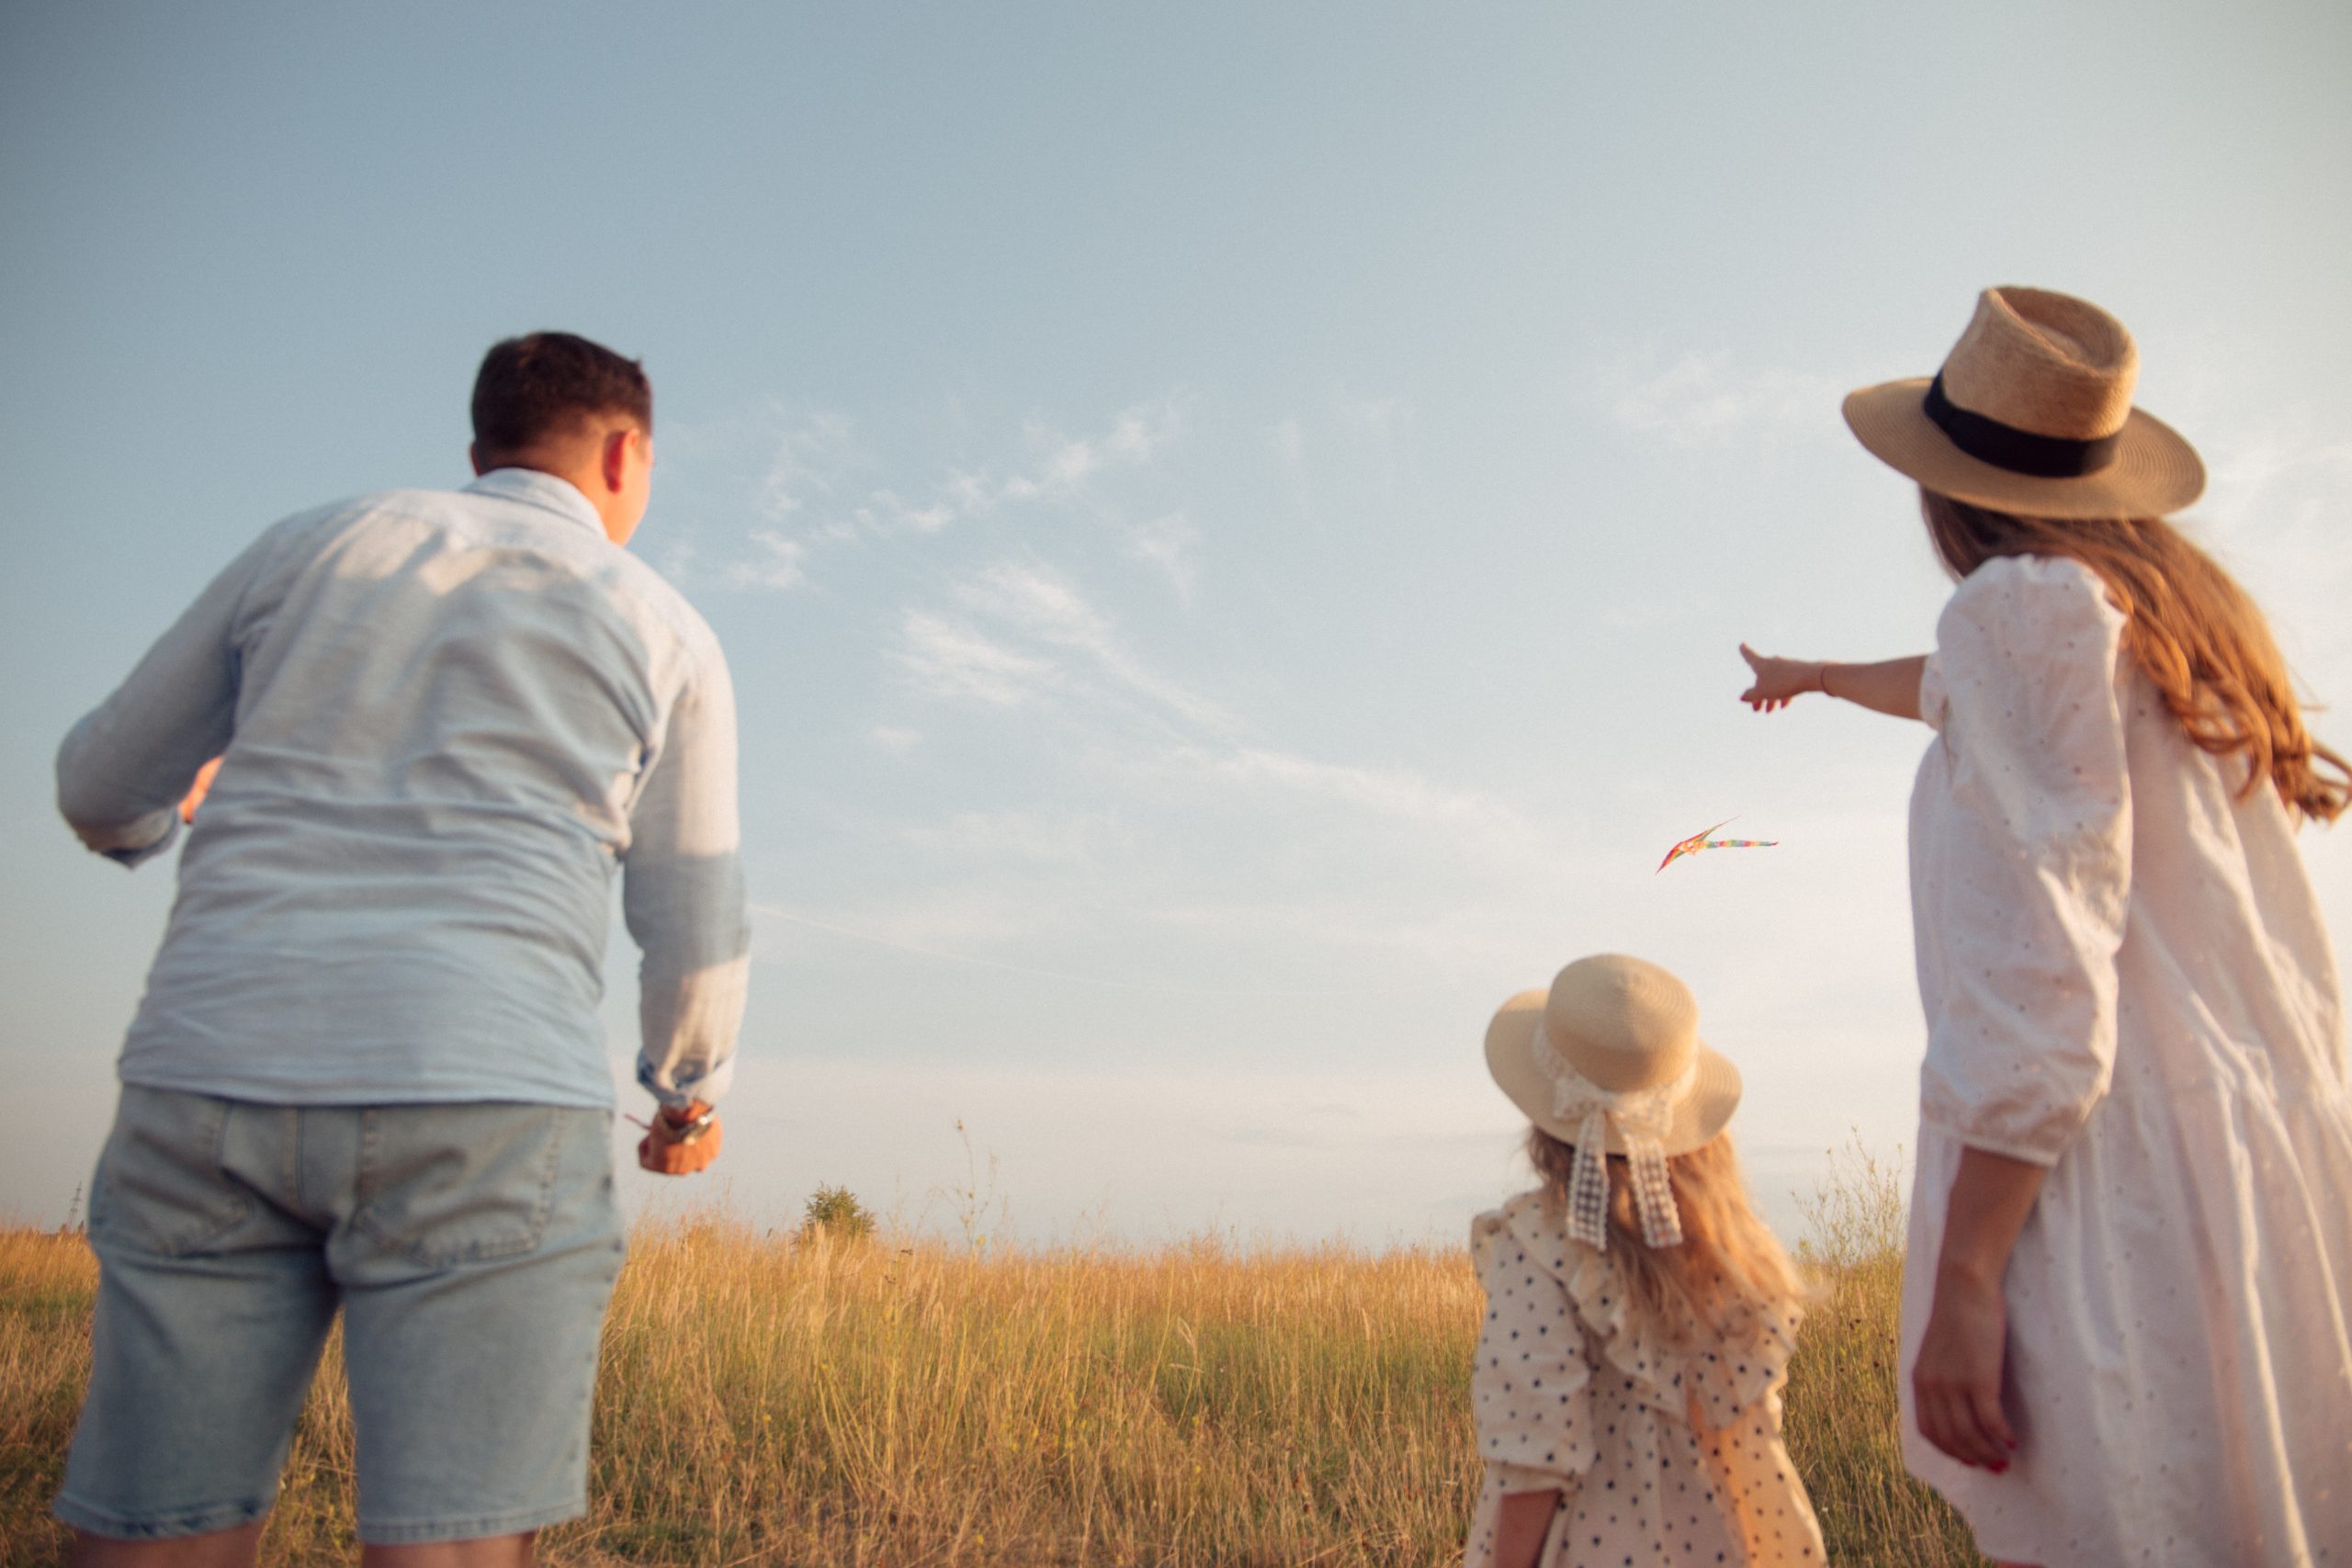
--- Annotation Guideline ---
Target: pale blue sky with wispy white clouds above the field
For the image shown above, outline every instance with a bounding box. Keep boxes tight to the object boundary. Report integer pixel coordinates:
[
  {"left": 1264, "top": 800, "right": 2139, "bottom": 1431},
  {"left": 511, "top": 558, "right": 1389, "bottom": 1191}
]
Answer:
[{"left": 0, "top": 0, "right": 2352, "bottom": 1246}]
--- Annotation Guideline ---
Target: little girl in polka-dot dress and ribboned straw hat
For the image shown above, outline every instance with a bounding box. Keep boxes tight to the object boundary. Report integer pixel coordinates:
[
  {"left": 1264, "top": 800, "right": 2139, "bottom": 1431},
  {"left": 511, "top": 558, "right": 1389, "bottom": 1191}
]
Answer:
[{"left": 1465, "top": 954, "right": 1823, "bottom": 1568}]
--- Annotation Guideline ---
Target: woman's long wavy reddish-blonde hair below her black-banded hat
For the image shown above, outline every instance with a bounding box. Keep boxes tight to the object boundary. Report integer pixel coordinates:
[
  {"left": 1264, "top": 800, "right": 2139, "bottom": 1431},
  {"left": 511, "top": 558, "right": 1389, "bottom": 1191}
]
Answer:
[{"left": 1919, "top": 489, "right": 2352, "bottom": 823}]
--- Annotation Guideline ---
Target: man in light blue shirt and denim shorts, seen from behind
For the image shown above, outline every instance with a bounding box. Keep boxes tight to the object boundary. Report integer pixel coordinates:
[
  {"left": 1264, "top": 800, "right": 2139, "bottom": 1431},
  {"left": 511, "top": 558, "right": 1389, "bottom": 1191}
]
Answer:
[{"left": 56, "top": 332, "right": 748, "bottom": 1568}]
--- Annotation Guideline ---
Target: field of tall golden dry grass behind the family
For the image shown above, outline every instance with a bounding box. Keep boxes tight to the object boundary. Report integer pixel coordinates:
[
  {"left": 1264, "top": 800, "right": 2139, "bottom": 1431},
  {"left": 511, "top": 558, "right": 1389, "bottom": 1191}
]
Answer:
[{"left": 0, "top": 1146, "right": 1981, "bottom": 1568}]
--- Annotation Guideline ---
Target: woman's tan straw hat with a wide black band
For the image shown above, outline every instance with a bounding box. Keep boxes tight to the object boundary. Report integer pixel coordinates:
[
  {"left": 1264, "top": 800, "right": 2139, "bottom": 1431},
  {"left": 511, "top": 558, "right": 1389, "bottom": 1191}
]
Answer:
[{"left": 1847, "top": 287, "right": 2204, "bottom": 517}]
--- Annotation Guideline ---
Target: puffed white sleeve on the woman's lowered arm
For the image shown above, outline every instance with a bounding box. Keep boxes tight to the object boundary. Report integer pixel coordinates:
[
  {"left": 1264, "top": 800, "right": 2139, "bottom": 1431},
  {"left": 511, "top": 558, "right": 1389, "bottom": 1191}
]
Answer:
[{"left": 1912, "top": 558, "right": 2131, "bottom": 1166}]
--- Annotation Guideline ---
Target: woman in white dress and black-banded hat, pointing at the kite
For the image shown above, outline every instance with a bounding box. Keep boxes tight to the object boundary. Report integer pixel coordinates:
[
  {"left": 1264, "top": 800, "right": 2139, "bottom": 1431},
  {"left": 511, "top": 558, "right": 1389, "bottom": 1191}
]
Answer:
[{"left": 1743, "top": 289, "right": 2352, "bottom": 1568}]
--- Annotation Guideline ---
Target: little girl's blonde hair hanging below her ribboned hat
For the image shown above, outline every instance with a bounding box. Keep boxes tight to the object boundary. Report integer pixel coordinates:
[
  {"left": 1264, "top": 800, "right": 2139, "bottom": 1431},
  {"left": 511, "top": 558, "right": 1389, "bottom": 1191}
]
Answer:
[{"left": 1526, "top": 1126, "right": 1804, "bottom": 1337}]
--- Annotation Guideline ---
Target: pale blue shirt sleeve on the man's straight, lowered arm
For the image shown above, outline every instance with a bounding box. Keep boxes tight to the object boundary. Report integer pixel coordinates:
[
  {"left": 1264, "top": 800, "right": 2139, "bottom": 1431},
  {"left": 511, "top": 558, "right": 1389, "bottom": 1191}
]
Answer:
[{"left": 621, "top": 639, "right": 751, "bottom": 1107}]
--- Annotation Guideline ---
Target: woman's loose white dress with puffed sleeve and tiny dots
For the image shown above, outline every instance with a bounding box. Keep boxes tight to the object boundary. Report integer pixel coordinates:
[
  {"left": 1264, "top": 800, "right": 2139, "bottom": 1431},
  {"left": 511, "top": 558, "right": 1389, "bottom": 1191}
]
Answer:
[{"left": 1903, "top": 558, "right": 2352, "bottom": 1568}]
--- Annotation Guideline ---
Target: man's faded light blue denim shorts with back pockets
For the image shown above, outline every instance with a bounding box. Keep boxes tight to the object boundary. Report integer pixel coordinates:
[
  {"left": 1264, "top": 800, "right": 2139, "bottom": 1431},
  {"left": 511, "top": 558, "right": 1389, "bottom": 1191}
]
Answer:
[{"left": 56, "top": 1084, "right": 623, "bottom": 1544}]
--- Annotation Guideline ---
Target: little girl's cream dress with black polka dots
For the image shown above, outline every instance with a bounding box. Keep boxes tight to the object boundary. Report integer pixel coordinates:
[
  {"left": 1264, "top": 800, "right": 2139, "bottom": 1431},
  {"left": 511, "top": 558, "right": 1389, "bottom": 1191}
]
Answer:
[{"left": 1465, "top": 1192, "right": 1823, "bottom": 1568}]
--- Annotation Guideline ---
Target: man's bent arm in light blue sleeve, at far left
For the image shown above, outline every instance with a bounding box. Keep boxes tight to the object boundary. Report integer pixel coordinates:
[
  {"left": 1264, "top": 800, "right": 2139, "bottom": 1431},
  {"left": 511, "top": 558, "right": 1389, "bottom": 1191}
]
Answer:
[{"left": 56, "top": 529, "right": 277, "bottom": 865}]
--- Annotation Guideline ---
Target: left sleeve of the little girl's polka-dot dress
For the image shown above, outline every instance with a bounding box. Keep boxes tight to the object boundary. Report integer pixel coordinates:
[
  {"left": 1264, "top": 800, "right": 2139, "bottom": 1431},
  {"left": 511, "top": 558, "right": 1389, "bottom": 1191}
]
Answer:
[{"left": 1470, "top": 1215, "right": 1597, "bottom": 1493}]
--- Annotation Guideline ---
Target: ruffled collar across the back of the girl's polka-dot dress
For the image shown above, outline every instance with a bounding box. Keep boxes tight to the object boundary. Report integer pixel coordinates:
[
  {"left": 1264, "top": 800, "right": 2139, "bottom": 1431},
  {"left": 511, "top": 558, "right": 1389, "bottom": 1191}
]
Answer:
[{"left": 1470, "top": 1192, "right": 1804, "bottom": 1432}]
